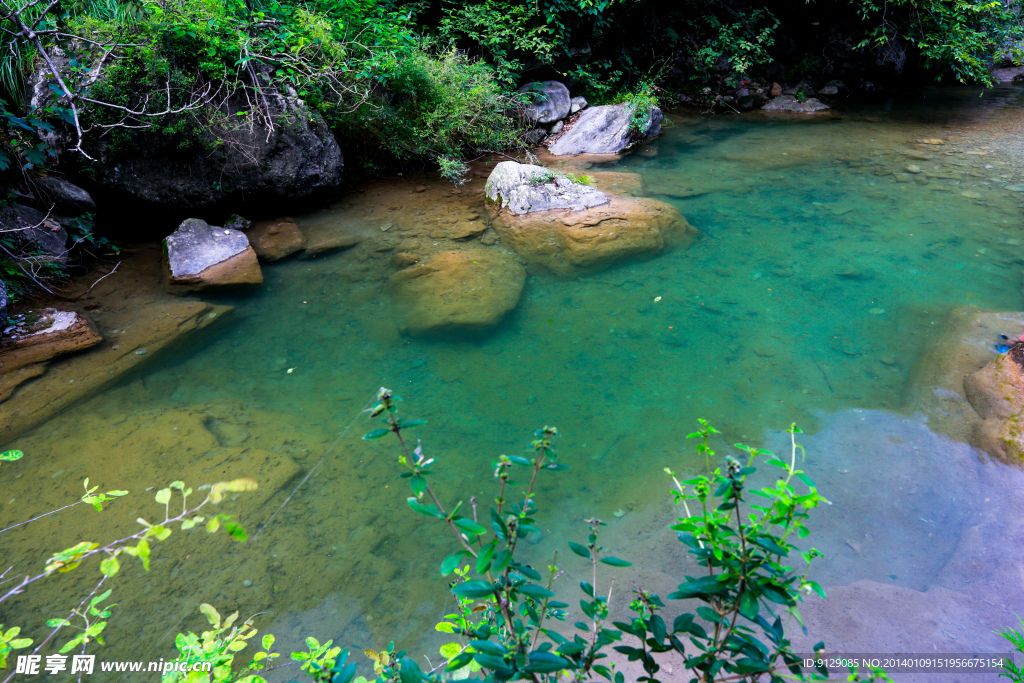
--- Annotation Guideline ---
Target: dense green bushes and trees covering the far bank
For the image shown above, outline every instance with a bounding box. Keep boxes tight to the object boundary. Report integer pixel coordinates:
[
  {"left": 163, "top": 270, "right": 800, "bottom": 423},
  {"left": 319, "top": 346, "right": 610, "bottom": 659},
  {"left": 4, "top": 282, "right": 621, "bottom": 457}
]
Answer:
[{"left": 0, "top": 0, "right": 1022, "bottom": 299}]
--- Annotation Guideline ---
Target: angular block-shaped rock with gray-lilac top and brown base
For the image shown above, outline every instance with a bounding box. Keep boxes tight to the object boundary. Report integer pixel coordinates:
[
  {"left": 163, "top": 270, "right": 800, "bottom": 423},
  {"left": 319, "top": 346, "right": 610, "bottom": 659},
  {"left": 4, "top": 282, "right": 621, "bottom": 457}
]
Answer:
[{"left": 164, "top": 218, "right": 263, "bottom": 294}]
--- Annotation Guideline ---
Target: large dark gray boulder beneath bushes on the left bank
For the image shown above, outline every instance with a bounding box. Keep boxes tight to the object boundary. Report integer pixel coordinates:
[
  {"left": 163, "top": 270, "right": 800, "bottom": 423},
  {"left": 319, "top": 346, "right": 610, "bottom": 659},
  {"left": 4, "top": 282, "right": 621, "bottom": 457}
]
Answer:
[{"left": 28, "top": 60, "right": 344, "bottom": 212}]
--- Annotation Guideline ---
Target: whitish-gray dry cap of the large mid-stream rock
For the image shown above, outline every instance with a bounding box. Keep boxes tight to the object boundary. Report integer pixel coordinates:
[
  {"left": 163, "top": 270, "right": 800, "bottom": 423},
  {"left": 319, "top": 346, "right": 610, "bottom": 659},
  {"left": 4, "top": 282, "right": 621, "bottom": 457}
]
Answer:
[{"left": 483, "top": 161, "right": 608, "bottom": 216}]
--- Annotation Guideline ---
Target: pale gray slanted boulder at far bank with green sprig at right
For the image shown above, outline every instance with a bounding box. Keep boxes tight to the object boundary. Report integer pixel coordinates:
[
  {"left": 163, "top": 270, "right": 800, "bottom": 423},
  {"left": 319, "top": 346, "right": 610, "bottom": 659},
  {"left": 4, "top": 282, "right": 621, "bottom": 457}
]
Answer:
[{"left": 548, "top": 103, "right": 664, "bottom": 157}]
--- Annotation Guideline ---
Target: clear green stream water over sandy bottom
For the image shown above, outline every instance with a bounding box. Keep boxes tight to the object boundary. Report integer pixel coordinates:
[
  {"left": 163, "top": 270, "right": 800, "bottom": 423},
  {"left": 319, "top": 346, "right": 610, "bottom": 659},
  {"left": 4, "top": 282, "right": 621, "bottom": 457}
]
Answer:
[{"left": 0, "top": 83, "right": 1024, "bottom": 683}]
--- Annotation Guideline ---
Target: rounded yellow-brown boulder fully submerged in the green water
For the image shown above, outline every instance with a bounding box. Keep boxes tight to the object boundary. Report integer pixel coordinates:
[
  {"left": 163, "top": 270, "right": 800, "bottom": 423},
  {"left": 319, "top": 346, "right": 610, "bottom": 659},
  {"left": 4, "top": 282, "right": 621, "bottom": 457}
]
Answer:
[{"left": 388, "top": 248, "right": 526, "bottom": 335}]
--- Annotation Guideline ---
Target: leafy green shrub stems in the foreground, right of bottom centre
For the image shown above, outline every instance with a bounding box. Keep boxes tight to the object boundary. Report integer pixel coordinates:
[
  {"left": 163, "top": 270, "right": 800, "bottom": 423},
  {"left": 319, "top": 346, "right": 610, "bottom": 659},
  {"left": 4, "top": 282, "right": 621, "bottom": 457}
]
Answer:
[{"left": 350, "top": 388, "right": 889, "bottom": 683}]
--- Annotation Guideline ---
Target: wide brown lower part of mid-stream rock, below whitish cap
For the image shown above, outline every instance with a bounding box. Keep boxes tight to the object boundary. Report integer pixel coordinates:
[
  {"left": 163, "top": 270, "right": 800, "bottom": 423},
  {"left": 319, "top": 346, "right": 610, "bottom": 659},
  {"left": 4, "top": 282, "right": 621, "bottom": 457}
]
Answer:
[{"left": 490, "top": 197, "right": 696, "bottom": 275}]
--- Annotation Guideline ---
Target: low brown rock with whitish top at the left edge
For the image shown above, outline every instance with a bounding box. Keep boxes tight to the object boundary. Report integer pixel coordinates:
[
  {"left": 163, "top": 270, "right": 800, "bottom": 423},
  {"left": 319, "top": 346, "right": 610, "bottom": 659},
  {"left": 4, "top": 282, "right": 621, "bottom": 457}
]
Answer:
[{"left": 0, "top": 308, "right": 103, "bottom": 374}]
